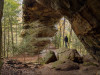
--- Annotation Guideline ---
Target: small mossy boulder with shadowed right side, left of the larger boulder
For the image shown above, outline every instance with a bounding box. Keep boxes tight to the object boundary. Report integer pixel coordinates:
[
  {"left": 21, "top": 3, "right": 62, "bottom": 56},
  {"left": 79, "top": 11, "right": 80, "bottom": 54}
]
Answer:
[{"left": 44, "top": 51, "right": 57, "bottom": 64}]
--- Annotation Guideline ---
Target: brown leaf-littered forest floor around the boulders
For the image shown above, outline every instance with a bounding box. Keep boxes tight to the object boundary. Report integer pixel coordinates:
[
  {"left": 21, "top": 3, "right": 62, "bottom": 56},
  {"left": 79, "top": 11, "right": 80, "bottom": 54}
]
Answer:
[{"left": 1, "top": 45, "right": 100, "bottom": 75}]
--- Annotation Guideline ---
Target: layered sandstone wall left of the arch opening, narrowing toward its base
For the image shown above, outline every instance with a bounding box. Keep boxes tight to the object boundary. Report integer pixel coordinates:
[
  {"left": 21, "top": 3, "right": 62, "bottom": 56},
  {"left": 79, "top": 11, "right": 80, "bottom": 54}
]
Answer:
[{"left": 22, "top": 0, "right": 62, "bottom": 52}]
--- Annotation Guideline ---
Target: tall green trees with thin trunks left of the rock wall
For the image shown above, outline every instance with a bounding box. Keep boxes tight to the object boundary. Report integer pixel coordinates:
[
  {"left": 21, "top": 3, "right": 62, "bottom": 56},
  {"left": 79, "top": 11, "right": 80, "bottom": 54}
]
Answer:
[{"left": 2, "top": 0, "right": 21, "bottom": 55}]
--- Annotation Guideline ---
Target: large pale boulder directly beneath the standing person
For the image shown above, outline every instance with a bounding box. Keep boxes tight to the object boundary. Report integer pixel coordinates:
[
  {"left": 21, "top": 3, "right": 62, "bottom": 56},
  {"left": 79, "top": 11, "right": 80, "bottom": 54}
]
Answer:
[{"left": 57, "top": 48, "right": 83, "bottom": 63}]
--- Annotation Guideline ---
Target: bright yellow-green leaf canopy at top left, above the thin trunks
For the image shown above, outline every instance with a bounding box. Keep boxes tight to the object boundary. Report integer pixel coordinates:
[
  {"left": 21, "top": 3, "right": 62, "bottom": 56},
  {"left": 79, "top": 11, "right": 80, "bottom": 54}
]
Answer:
[{"left": 3, "top": 0, "right": 21, "bottom": 25}]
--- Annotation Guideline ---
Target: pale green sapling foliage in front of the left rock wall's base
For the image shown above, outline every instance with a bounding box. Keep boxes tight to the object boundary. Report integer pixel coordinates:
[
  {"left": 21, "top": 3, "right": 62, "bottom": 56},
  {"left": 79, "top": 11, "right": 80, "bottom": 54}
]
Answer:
[{"left": 17, "top": 35, "right": 35, "bottom": 56}]
